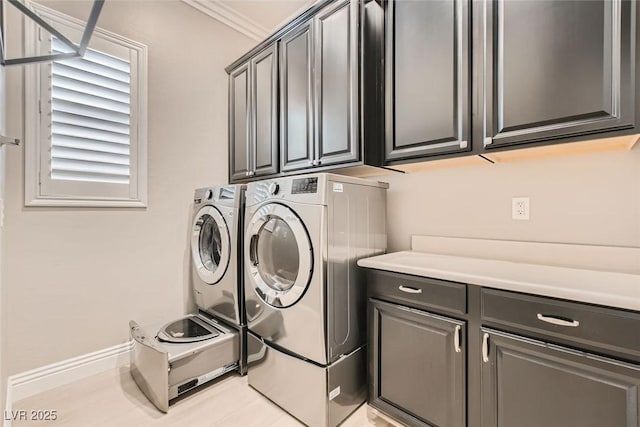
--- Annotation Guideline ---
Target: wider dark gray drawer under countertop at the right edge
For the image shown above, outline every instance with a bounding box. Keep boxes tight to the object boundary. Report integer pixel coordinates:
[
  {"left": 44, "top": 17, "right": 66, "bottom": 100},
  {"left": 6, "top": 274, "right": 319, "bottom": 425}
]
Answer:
[{"left": 482, "top": 288, "right": 640, "bottom": 359}]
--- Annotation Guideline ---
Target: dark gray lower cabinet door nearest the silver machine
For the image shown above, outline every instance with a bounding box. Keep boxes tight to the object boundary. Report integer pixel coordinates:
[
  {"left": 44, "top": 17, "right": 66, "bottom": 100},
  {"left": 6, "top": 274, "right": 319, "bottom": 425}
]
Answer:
[{"left": 369, "top": 300, "right": 466, "bottom": 427}]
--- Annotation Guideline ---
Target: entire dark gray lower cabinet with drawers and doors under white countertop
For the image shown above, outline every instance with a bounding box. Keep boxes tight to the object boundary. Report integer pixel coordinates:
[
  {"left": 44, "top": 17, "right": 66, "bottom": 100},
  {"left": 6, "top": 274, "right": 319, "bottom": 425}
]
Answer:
[{"left": 367, "top": 270, "right": 640, "bottom": 427}]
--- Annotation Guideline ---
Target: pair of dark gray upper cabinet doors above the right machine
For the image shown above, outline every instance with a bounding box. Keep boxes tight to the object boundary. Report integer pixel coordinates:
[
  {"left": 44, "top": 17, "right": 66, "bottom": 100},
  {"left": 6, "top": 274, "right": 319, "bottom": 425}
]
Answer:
[{"left": 280, "top": 0, "right": 360, "bottom": 172}]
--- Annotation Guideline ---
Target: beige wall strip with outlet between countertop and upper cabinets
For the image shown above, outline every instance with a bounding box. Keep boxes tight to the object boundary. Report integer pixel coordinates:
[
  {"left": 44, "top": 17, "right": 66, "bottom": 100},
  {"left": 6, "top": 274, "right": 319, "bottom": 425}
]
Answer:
[{"left": 380, "top": 147, "right": 640, "bottom": 251}]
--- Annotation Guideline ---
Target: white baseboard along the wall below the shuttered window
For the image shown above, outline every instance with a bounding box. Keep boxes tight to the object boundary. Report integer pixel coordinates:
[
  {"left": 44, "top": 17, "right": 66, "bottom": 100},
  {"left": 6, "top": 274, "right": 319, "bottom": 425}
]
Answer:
[{"left": 4, "top": 341, "right": 133, "bottom": 427}]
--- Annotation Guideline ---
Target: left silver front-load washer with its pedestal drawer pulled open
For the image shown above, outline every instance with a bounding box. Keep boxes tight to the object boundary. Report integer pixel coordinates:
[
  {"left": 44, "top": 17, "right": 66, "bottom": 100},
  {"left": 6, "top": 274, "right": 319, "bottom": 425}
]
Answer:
[{"left": 129, "top": 185, "right": 246, "bottom": 412}]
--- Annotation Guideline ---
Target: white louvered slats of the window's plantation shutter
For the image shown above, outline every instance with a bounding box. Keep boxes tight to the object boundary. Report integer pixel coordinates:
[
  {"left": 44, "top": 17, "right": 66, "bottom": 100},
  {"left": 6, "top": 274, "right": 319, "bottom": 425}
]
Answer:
[{"left": 50, "top": 38, "right": 131, "bottom": 184}]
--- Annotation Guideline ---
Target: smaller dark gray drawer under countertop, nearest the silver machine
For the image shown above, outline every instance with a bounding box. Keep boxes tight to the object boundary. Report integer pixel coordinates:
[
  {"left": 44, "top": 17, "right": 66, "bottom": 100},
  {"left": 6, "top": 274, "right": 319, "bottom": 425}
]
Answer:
[{"left": 368, "top": 271, "right": 467, "bottom": 313}]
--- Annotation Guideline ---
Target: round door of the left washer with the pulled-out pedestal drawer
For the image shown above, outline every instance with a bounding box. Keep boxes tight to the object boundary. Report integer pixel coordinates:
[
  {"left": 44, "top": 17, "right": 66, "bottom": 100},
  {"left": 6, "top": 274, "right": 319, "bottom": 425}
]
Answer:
[{"left": 191, "top": 206, "right": 231, "bottom": 285}]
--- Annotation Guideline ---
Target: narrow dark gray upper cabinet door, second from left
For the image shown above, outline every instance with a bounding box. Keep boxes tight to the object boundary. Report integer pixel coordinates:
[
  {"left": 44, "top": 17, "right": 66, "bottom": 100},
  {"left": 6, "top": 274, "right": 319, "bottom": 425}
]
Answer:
[{"left": 251, "top": 43, "right": 278, "bottom": 176}]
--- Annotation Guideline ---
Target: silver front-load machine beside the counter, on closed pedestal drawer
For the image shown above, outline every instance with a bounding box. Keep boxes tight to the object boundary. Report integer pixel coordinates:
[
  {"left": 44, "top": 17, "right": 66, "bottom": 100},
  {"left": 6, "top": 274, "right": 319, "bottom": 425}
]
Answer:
[{"left": 244, "top": 173, "right": 388, "bottom": 426}]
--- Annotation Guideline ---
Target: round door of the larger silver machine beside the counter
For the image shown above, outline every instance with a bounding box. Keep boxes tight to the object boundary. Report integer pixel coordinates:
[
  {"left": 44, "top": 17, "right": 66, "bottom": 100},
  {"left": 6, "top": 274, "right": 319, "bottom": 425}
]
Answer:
[{"left": 245, "top": 203, "right": 313, "bottom": 308}]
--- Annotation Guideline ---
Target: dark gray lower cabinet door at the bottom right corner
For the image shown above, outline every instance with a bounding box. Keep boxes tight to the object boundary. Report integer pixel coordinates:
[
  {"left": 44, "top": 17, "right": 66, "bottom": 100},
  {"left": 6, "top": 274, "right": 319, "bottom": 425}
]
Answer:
[{"left": 481, "top": 329, "right": 640, "bottom": 427}]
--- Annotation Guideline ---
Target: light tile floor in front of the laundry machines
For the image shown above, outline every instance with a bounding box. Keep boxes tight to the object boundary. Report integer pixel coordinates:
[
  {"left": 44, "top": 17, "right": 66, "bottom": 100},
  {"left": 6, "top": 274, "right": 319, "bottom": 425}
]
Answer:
[{"left": 12, "top": 367, "right": 398, "bottom": 427}]
